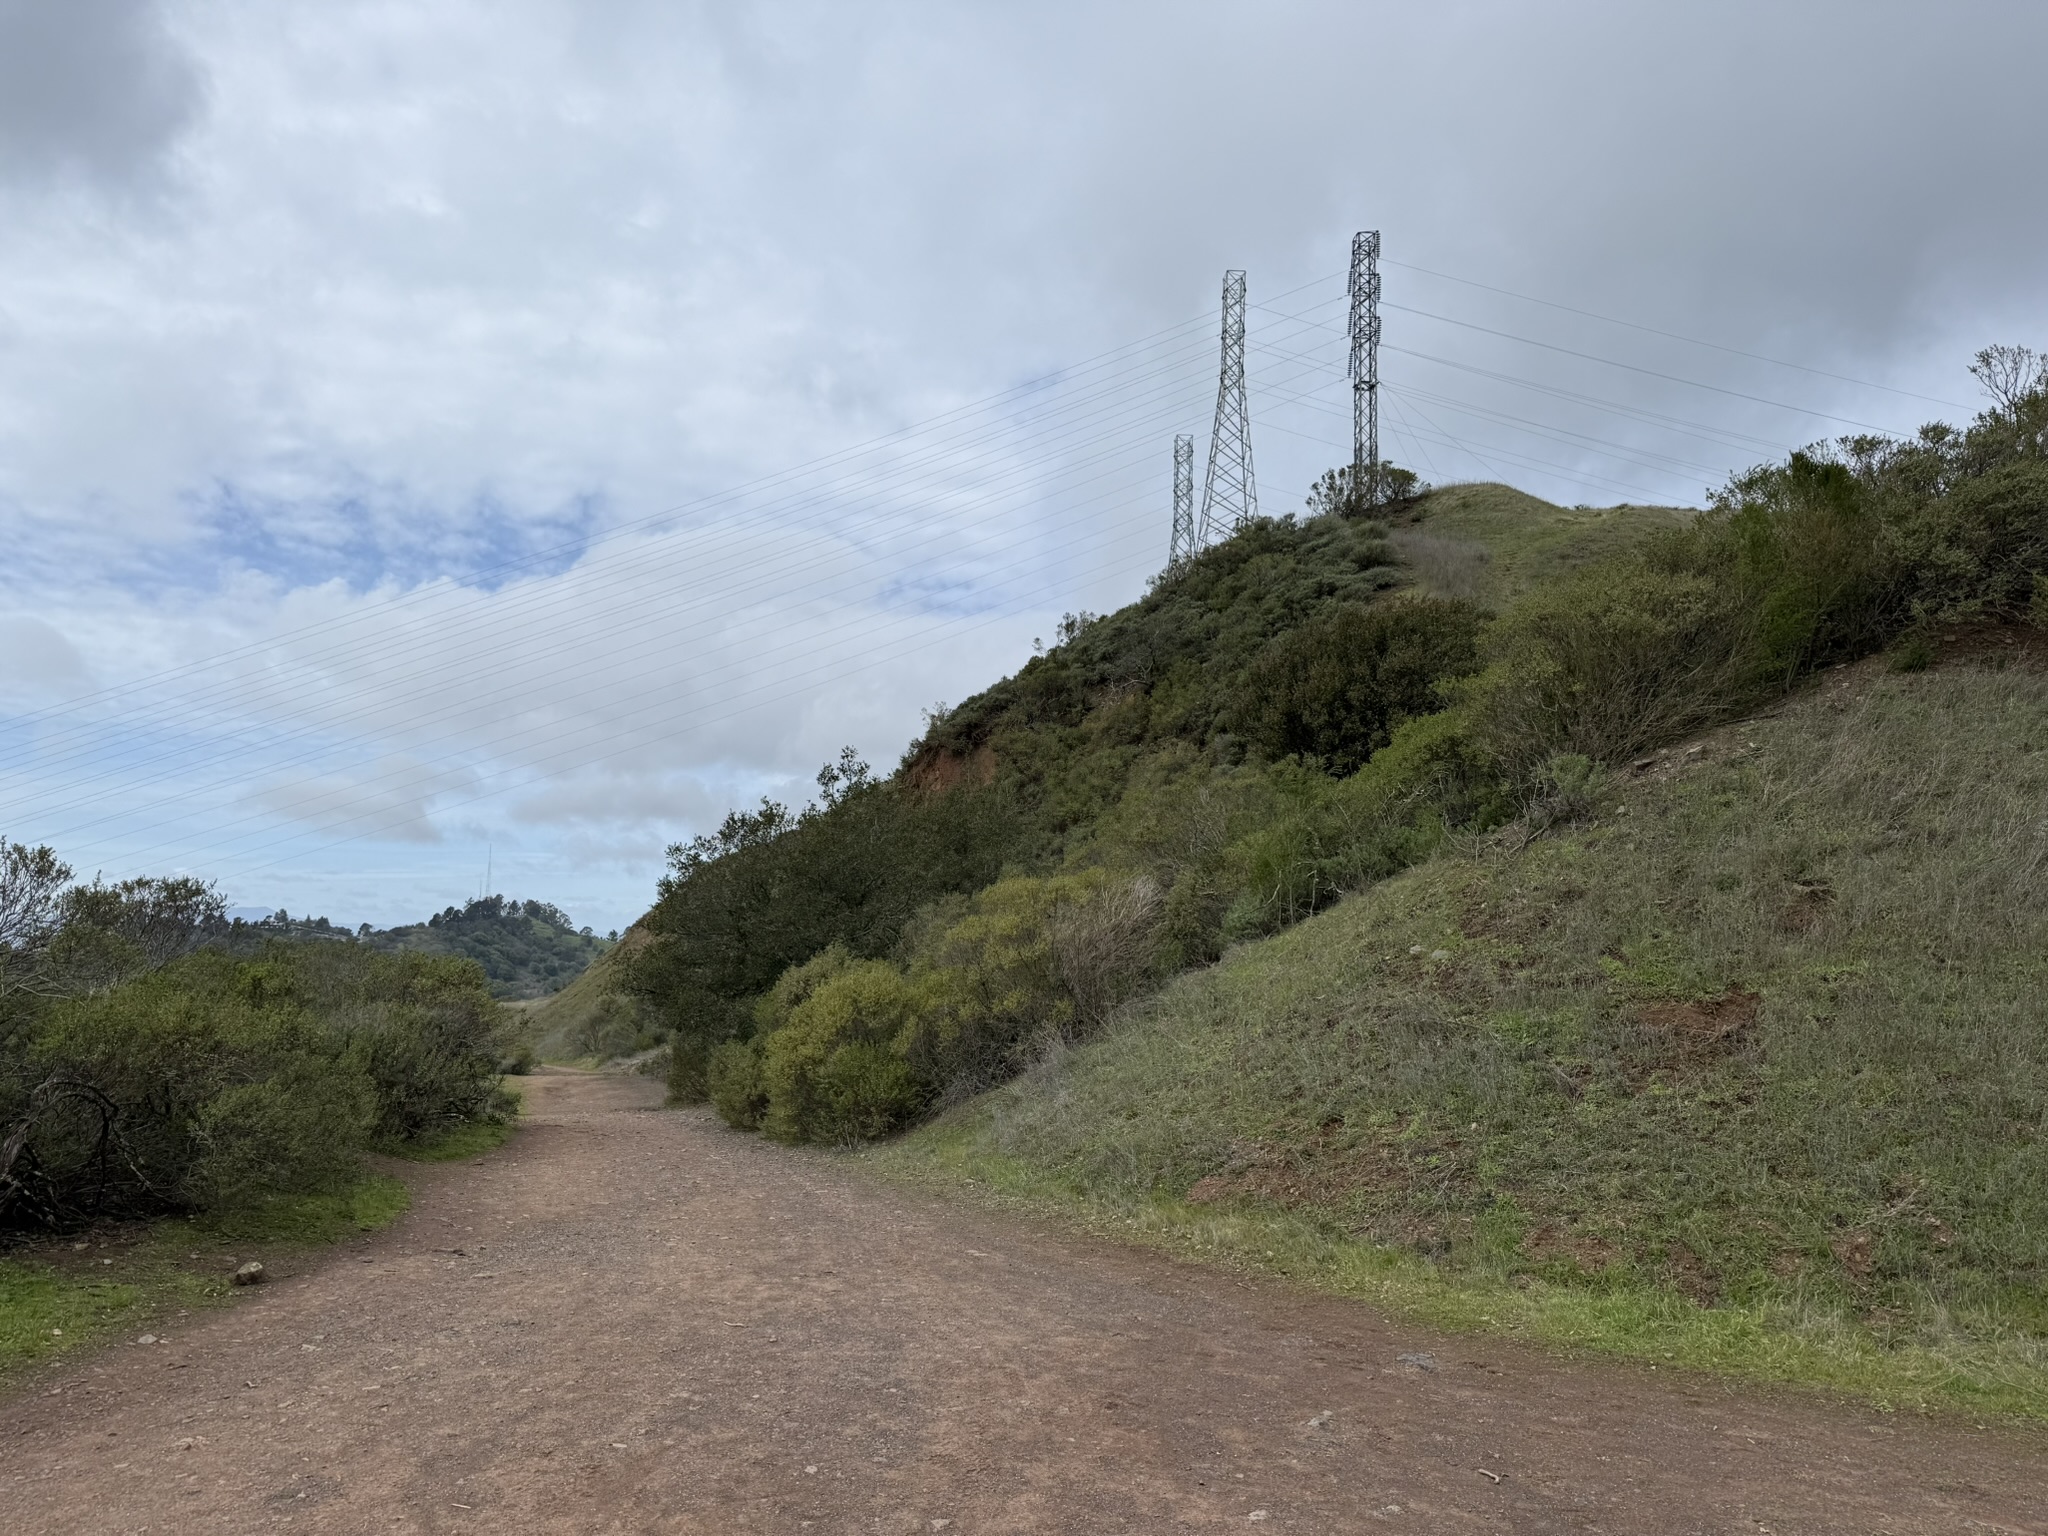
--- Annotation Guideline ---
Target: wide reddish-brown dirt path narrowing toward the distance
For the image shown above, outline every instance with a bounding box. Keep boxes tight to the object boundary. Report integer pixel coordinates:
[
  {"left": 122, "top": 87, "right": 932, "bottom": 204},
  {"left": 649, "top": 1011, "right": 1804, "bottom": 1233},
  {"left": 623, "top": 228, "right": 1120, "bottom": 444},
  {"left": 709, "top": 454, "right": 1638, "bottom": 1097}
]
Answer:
[{"left": 0, "top": 1075, "right": 2048, "bottom": 1536}]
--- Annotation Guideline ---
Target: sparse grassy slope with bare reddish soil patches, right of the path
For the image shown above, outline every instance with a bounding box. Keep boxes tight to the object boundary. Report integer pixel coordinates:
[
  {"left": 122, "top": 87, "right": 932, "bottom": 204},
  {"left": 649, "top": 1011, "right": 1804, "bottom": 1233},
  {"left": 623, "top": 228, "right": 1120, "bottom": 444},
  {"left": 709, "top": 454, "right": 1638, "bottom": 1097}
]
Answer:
[{"left": 874, "top": 666, "right": 2048, "bottom": 1419}]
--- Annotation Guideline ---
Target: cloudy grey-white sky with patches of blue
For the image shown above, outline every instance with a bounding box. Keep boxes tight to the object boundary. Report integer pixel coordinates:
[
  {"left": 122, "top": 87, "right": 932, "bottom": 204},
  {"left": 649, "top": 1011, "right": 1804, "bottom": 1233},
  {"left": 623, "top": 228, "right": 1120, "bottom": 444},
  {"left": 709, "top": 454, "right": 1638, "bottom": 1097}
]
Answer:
[{"left": 0, "top": 0, "right": 2048, "bottom": 930}]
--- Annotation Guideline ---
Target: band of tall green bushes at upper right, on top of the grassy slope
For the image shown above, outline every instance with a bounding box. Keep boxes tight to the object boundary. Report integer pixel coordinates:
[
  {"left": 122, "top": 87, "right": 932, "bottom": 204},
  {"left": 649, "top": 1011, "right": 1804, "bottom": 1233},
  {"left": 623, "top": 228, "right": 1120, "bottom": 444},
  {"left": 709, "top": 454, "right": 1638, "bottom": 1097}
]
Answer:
[{"left": 1468, "top": 385, "right": 2048, "bottom": 782}]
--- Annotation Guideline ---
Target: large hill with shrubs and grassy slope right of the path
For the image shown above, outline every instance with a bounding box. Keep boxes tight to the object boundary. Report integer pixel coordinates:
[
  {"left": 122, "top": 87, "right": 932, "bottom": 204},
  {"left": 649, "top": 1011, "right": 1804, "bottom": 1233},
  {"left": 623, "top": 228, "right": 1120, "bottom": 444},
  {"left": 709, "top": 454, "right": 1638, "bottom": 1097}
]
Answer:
[{"left": 618, "top": 352, "right": 2048, "bottom": 1415}]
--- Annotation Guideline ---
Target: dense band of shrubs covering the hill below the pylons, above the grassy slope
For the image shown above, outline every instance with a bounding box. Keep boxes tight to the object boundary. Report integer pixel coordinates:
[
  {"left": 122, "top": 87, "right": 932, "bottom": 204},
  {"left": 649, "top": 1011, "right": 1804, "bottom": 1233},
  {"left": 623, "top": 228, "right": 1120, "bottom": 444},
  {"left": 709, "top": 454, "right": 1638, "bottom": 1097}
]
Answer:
[{"left": 633, "top": 354, "right": 2048, "bottom": 1163}]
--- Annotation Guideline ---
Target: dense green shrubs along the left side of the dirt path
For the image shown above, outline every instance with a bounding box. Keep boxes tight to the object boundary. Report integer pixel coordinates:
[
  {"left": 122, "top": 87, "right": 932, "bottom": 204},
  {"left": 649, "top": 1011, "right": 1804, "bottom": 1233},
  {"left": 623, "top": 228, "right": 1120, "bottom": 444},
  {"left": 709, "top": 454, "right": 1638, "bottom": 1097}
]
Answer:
[{"left": 0, "top": 846, "right": 512, "bottom": 1227}]
